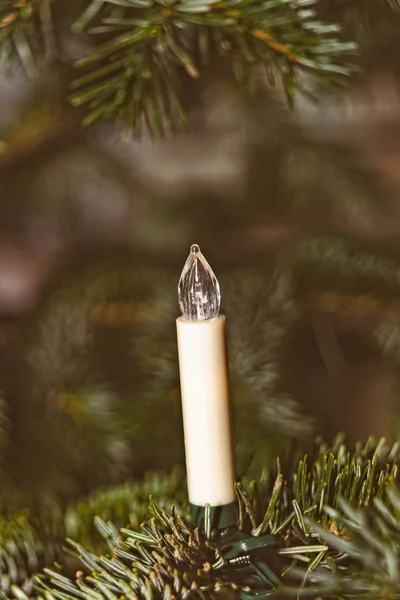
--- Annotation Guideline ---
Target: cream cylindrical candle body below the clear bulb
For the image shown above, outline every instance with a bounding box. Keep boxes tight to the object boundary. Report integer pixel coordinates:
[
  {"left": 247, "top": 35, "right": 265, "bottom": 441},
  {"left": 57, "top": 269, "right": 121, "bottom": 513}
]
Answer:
[{"left": 177, "top": 315, "right": 235, "bottom": 506}]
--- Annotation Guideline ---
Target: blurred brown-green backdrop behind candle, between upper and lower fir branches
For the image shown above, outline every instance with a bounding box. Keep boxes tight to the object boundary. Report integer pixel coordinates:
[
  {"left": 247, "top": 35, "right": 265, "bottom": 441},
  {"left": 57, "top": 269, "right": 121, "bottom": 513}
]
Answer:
[{"left": 0, "top": 0, "right": 400, "bottom": 506}]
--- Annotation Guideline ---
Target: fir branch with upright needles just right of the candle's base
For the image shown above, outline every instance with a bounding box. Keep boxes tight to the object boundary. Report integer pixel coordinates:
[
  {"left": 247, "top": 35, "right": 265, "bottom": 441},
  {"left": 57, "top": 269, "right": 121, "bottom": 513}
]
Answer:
[{"left": 242, "top": 436, "right": 399, "bottom": 538}]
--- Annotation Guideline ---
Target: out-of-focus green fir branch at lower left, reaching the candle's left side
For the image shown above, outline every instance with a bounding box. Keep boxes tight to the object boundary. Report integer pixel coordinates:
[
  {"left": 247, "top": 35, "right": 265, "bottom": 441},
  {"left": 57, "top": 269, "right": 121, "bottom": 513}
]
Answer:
[{"left": 0, "top": 467, "right": 187, "bottom": 598}]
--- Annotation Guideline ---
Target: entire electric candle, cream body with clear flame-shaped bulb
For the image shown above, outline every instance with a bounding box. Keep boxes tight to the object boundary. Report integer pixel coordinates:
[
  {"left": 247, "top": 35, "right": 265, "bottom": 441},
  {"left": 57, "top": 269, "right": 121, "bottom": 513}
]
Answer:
[{"left": 177, "top": 244, "right": 235, "bottom": 524}]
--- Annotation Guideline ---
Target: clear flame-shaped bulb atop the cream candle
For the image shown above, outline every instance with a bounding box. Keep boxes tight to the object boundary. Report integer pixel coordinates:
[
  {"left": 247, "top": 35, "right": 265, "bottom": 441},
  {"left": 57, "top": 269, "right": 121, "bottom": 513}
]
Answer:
[{"left": 178, "top": 244, "right": 221, "bottom": 321}]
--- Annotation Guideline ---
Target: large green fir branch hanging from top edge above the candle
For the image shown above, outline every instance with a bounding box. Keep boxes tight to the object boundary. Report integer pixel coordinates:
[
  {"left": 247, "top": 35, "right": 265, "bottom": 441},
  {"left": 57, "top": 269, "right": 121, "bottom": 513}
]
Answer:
[{"left": 71, "top": 0, "right": 355, "bottom": 135}]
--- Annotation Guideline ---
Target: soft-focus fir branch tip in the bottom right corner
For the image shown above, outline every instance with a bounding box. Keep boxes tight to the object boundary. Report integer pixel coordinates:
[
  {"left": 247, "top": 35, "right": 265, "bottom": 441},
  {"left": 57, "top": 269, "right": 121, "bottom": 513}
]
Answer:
[{"left": 284, "top": 486, "right": 400, "bottom": 600}]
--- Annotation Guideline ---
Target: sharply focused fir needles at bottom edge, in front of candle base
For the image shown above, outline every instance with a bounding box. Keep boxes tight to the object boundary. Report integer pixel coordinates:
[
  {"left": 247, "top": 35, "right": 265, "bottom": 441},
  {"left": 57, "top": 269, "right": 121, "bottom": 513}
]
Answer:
[{"left": 41, "top": 502, "right": 230, "bottom": 599}]
